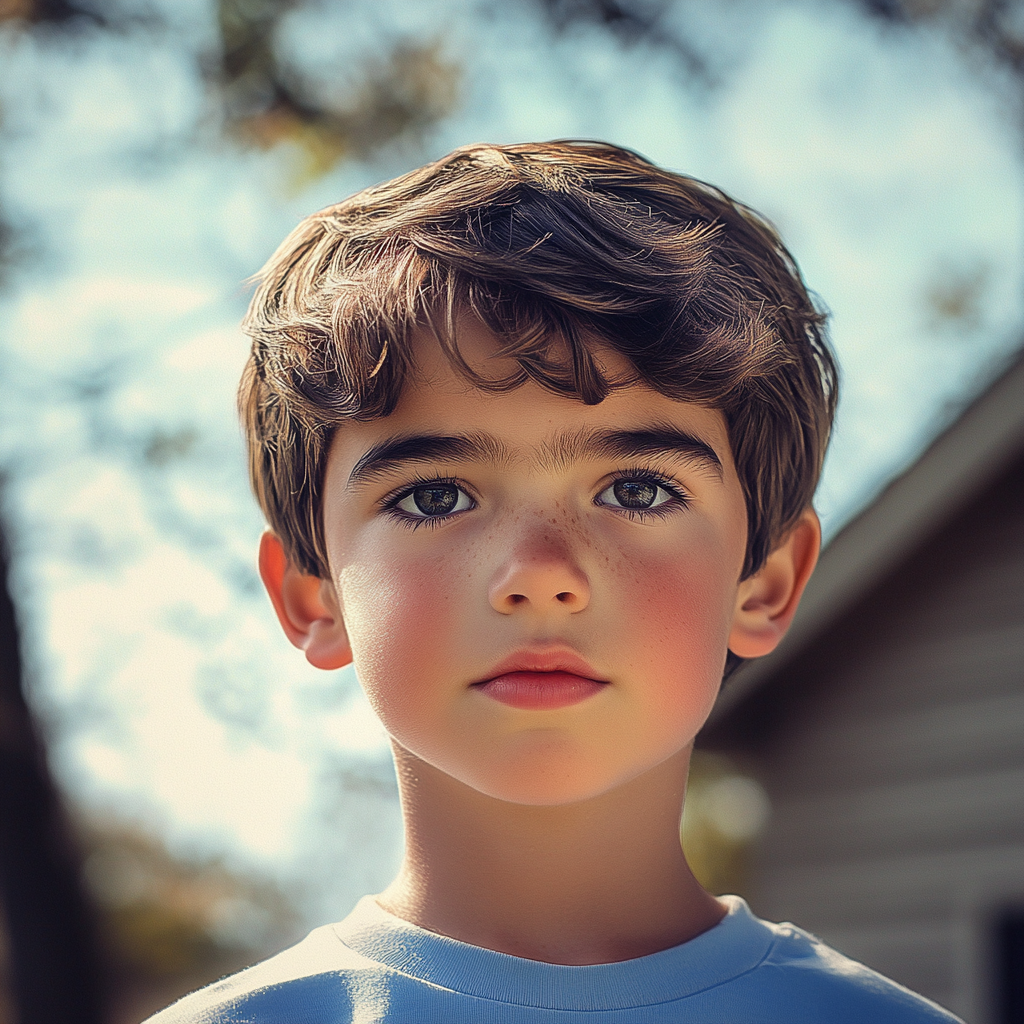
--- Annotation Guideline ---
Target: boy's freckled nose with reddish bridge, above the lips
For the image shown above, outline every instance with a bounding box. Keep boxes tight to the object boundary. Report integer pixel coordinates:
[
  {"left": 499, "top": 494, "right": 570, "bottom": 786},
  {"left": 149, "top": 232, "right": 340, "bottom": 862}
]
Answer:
[{"left": 488, "top": 535, "right": 590, "bottom": 615}]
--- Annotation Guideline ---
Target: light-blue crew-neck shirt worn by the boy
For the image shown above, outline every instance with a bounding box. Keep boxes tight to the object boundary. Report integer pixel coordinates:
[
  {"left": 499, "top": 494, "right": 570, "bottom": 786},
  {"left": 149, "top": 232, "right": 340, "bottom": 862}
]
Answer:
[{"left": 147, "top": 896, "right": 957, "bottom": 1024}]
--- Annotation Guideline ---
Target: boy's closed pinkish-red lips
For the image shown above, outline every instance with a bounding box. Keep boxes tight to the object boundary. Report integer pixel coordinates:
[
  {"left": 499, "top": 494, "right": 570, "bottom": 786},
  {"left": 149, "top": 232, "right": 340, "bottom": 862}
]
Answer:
[{"left": 472, "top": 650, "right": 608, "bottom": 711}]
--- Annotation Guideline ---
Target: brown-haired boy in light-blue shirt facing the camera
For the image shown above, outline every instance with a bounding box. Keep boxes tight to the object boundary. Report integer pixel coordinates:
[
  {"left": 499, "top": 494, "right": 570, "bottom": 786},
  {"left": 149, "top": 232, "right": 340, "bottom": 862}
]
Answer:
[{"left": 148, "top": 142, "right": 953, "bottom": 1024}]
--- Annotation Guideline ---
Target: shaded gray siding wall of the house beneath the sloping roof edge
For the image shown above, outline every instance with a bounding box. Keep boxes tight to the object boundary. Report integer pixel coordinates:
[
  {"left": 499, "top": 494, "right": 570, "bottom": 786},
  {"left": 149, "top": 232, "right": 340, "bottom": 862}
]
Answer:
[{"left": 713, "top": 460, "right": 1024, "bottom": 1022}]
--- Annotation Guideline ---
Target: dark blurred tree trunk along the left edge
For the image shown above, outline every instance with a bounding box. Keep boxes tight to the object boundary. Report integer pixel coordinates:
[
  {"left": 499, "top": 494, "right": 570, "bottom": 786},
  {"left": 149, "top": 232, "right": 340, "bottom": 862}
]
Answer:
[{"left": 0, "top": 520, "right": 103, "bottom": 1024}]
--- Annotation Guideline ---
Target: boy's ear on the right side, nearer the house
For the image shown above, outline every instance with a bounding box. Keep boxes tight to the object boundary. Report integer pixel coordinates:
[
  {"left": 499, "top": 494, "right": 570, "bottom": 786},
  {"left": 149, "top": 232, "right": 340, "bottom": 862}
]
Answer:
[{"left": 729, "top": 508, "right": 821, "bottom": 657}]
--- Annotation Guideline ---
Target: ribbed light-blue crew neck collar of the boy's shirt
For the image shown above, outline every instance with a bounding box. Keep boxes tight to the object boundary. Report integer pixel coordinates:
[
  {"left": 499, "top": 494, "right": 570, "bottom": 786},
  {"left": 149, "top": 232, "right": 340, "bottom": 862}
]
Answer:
[{"left": 333, "top": 896, "right": 774, "bottom": 1011}]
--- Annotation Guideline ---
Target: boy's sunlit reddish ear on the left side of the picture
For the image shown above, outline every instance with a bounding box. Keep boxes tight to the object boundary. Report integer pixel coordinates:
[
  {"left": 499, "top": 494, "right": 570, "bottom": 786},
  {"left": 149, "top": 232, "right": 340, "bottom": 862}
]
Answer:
[{"left": 259, "top": 530, "right": 352, "bottom": 669}]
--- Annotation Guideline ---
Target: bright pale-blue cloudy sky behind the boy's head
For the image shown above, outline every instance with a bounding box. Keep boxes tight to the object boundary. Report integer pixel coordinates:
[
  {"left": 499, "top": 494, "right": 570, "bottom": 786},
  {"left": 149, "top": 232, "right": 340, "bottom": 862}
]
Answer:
[{"left": 0, "top": 0, "right": 1024, "bottom": 916}]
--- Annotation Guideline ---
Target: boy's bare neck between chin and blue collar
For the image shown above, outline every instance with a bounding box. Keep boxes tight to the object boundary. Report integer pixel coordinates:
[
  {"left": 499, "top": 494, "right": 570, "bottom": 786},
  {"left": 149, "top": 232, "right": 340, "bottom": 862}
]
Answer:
[{"left": 378, "top": 745, "right": 724, "bottom": 965}]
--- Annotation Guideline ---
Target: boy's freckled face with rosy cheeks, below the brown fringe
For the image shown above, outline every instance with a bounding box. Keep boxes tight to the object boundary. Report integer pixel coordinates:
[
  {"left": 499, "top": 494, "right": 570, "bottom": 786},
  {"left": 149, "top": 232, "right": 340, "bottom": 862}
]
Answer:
[{"left": 324, "top": 325, "right": 746, "bottom": 805}]
